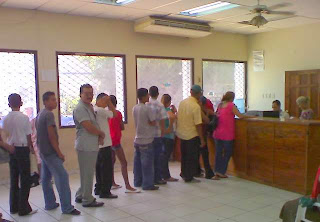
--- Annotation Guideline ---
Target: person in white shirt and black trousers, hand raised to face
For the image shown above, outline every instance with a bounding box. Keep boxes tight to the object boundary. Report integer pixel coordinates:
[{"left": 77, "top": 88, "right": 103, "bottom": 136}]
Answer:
[{"left": 94, "top": 93, "right": 118, "bottom": 198}]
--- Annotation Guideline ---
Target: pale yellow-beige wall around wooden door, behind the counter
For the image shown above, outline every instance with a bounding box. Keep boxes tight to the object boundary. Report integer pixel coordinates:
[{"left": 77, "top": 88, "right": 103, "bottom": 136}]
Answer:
[{"left": 248, "top": 23, "right": 320, "bottom": 110}]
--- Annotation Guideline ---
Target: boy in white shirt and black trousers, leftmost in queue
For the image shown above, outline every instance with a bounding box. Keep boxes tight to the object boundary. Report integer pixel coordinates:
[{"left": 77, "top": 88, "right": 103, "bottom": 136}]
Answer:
[{"left": 3, "top": 93, "right": 37, "bottom": 216}]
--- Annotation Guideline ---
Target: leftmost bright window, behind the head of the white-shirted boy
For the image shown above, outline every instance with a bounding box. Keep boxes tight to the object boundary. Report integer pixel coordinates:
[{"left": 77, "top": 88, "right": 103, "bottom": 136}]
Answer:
[{"left": 0, "top": 50, "right": 38, "bottom": 126}]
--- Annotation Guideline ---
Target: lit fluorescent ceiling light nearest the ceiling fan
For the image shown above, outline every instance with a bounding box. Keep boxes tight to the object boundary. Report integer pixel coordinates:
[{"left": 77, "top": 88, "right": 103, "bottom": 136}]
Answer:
[{"left": 180, "top": 1, "right": 239, "bottom": 17}]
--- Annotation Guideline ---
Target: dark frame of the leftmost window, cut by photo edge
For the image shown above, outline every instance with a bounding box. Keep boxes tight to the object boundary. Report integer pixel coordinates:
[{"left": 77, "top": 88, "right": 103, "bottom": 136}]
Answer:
[{"left": 0, "top": 48, "right": 40, "bottom": 113}]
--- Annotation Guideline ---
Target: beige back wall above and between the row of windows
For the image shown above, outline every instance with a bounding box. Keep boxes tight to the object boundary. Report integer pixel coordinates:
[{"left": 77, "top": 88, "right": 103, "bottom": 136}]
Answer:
[{"left": 0, "top": 8, "right": 247, "bottom": 181}]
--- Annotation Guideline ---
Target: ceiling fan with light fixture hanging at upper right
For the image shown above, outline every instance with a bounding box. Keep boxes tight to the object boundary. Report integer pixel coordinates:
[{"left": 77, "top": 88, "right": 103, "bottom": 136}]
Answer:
[{"left": 239, "top": 0, "right": 295, "bottom": 28}]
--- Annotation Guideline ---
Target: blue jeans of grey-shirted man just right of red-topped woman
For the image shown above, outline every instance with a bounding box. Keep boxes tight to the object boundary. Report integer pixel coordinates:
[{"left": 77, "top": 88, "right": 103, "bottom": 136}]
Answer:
[{"left": 133, "top": 143, "right": 154, "bottom": 189}]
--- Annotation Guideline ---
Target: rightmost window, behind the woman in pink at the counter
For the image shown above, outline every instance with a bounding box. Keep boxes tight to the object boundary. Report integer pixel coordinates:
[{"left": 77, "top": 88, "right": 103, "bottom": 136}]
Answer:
[{"left": 203, "top": 60, "right": 246, "bottom": 113}]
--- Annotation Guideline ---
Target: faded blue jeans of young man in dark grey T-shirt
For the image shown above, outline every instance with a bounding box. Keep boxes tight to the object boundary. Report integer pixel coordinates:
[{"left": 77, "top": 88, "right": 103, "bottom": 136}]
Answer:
[{"left": 41, "top": 154, "right": 74, "bottom": 213}]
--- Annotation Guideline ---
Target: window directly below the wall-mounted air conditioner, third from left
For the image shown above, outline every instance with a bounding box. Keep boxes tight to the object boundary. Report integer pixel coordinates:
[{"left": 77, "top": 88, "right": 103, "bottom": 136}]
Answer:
[{"left": 137, "top": 56, "right": 193, "bottom": 107}]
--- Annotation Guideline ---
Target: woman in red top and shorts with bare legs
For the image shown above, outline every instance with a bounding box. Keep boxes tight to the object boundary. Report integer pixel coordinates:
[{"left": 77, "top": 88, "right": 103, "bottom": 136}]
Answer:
[{"left": 109, "top": 95, "right": 140, "bottom": 193}]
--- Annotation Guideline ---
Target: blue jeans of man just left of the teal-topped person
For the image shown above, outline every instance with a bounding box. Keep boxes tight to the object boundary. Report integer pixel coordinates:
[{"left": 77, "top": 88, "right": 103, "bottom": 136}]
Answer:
[{"left": 153, "top": 137, "right": 163, "bottom": 183}]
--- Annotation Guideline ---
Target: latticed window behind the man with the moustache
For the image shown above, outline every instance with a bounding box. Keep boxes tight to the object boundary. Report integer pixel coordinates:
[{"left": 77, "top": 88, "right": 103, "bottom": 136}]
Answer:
[{"left": 57, "top": 53, "right": 126, "bottom": 127}]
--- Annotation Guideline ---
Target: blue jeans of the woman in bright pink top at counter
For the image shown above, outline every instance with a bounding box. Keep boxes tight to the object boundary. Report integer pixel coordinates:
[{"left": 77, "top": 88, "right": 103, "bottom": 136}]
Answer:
[{"left": 214, "top": 139, "right": 233, "bottom": 175}]
